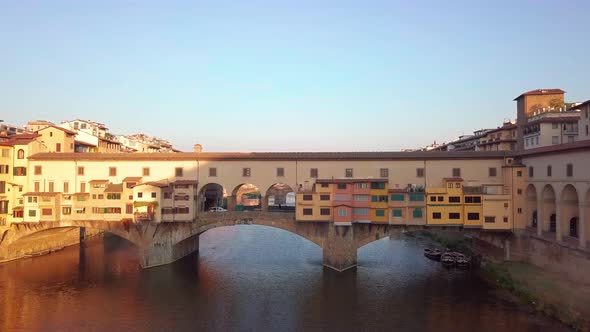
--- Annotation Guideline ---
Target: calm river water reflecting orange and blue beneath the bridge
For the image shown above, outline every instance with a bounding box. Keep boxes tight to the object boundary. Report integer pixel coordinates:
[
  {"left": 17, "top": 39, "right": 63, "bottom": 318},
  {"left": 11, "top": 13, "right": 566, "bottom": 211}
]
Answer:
[{"left": 0, "top": 225, "right": 568, "bottom": 332}]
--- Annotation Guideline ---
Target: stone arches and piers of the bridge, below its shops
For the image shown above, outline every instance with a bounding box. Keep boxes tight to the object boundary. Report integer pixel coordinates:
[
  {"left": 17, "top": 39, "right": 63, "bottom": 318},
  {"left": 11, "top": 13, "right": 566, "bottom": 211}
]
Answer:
[{"left": 0, "top": 212, "right": 512, "bottom": 271}]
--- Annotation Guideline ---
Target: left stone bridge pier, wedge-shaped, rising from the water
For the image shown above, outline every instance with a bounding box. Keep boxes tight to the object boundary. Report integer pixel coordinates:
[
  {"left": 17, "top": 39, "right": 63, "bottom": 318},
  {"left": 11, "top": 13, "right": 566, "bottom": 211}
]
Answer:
[{"left": 139, "top": 235, "right": 199, "bottom": 269}]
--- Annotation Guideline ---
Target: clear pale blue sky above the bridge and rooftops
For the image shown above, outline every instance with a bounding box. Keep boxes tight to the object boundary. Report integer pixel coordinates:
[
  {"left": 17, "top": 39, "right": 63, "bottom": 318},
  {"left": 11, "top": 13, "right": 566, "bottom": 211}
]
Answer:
[{"left": 0, "top": 0, "right": 590, "bottom": 151}]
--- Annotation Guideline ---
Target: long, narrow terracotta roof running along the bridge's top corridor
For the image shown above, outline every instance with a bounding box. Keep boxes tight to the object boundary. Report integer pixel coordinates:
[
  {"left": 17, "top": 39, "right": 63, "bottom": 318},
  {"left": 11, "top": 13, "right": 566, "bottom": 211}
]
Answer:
[{"left": 29, "top": 151, "right": 513, "bottom": 161}]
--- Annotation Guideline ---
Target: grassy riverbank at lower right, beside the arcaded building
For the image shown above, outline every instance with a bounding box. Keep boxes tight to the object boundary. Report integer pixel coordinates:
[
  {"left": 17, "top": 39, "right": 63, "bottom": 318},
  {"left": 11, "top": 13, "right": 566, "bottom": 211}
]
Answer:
[{"left": 413, "top": 232, "right": 590, "bottom": 331}]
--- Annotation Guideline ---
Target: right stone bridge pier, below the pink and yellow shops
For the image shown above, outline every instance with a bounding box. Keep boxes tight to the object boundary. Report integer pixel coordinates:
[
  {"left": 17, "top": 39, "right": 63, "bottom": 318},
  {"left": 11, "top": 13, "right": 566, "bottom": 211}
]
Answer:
[{"left": 323, "top": 224, "right": 357, "bottom": 272}]
